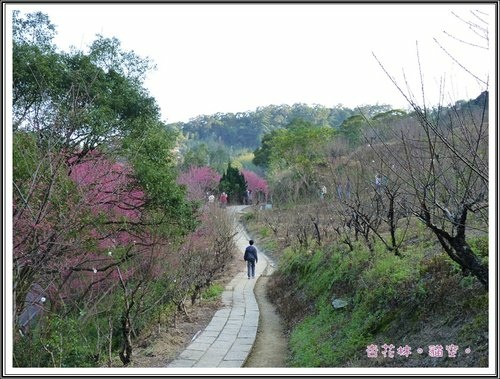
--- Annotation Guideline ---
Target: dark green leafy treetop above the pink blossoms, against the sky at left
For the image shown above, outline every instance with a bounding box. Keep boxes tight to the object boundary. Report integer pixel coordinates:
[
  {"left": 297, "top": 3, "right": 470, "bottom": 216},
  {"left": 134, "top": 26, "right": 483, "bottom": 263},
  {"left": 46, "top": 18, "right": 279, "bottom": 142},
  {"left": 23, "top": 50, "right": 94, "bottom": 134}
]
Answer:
[{"left": 12, "top": 13, "right": 160, "bottom": 151}]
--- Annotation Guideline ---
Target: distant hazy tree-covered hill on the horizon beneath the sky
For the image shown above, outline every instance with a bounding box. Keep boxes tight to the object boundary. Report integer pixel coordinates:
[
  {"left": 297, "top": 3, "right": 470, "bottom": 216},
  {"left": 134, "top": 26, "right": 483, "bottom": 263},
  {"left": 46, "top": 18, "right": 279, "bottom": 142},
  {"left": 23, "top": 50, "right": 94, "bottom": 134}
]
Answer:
[{"left": 172, "top": 104, "right": 394, "bottom": 174}]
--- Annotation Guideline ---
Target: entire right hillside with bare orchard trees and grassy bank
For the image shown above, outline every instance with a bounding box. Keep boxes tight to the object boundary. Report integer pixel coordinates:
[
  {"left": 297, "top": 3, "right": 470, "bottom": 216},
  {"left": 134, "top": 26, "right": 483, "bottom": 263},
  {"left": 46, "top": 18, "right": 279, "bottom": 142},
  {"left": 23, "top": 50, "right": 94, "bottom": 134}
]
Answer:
[{"left": 240, "top": 93, "right": 489, "bottom": 367}]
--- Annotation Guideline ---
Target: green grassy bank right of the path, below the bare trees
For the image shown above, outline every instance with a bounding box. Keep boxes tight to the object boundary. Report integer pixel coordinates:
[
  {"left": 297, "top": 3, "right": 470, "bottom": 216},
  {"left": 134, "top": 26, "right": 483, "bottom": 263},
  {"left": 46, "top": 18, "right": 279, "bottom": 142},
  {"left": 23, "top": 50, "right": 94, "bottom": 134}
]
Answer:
[{"left": 242, "top": 209, "right": 488, "bottom": 367}]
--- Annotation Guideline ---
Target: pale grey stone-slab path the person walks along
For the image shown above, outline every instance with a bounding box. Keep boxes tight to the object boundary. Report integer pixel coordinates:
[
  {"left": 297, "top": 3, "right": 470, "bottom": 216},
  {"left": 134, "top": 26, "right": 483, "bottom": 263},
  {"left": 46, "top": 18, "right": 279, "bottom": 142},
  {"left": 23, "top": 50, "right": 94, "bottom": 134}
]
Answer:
[{"left": 167, "top": 207, "right": 268, "bottom": 367}]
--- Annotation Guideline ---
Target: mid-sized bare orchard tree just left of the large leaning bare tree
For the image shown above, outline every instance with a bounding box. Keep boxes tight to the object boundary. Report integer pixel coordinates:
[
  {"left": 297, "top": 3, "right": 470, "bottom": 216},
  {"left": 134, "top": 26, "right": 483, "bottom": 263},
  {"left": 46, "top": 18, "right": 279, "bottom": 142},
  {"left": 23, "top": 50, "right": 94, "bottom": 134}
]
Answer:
[{"left": 336, "top": 142, "right": 418, "bottom": 256}]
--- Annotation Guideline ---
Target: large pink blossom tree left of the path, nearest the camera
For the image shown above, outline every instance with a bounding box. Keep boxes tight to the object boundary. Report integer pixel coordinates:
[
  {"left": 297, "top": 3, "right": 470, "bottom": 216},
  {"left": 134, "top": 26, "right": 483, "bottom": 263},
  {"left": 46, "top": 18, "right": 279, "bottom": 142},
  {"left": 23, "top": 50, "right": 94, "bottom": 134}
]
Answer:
[{"left": 13, "top": 144, "right": 184, "bottom": 364}]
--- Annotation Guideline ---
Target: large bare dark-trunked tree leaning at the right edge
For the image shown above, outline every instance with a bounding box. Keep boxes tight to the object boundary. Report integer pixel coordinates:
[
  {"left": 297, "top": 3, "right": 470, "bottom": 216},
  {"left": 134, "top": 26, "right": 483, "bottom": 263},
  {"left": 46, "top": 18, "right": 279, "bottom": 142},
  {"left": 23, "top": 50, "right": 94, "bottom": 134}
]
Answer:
[{"left": 377, "top": 9, "right": 488, "bottom": 288}]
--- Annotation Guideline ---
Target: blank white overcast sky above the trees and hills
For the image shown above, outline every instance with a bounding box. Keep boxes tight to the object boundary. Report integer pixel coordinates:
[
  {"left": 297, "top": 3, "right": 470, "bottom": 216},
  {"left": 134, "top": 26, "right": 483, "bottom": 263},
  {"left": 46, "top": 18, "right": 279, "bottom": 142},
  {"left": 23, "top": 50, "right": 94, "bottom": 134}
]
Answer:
[{"left": 7, "top": 3, "right": 496, "bottom": 122}]
